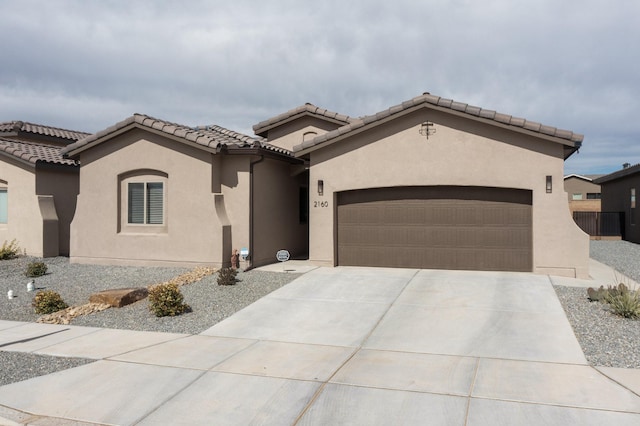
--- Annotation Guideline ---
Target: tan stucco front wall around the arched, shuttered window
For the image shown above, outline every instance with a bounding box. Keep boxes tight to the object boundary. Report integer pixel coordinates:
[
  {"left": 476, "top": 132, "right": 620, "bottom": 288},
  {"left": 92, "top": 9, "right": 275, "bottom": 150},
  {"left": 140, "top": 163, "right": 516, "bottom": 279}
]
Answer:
[{"left": 71, "top": 130, "right": 246, "bottom": 266}]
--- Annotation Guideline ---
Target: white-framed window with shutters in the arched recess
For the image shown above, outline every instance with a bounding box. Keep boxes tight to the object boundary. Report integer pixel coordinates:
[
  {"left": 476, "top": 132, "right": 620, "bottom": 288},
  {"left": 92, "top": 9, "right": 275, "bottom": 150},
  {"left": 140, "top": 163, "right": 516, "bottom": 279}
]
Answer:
[{"left": 127, "top": 182, "right": 164, "bottom": 225}]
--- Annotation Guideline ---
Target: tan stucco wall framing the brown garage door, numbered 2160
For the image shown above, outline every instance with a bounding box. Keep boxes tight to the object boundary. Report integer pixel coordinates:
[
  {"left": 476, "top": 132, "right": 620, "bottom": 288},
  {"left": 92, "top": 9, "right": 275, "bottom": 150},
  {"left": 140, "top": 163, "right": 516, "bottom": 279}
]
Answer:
[{"left": 309, "top": 110, "right": 589, "bottom": 278}]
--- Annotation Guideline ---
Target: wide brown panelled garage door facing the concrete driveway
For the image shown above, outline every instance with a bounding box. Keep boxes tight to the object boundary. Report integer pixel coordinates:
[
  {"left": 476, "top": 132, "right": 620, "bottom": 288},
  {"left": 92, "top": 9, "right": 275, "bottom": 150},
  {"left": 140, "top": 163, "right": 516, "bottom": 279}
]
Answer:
[{"left": 336, "top": 186, "right": 532, "bottom": 271}]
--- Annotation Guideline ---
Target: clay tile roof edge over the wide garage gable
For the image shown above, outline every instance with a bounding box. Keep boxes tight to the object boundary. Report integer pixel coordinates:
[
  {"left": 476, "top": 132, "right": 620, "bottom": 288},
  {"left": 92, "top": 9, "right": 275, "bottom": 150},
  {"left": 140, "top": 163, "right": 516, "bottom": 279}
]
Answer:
[{"left": 296, "top": 93, "right": 584, "bottom": 155}]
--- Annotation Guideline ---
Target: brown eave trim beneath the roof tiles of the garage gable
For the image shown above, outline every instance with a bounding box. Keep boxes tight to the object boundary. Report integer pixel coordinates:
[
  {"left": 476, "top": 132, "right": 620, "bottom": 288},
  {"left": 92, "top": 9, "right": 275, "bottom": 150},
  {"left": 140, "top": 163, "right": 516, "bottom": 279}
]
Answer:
[{"left": 294, "top": 103, "right": 582, "bottom": 160}]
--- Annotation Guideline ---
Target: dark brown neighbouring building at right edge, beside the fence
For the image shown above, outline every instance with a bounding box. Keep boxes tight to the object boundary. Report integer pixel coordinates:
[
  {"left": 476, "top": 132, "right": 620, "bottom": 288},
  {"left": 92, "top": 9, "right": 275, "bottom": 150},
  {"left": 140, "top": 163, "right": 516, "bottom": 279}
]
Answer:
[{"left": 594, "top": 164, "right": 640, "bottom": 244}]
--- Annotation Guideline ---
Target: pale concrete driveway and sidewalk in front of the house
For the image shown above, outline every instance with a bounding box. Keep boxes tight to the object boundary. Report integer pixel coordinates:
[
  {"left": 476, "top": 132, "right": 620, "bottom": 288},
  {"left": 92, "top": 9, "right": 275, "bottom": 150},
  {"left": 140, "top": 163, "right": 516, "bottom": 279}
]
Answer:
[{"left": 0, "top": 267, "right": 640, "bottom": 425}]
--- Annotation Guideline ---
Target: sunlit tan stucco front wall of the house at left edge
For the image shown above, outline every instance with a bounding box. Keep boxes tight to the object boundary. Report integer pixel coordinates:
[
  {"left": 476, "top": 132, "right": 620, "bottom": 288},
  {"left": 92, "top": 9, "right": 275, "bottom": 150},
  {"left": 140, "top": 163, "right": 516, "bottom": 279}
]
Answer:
[{"left": 0, "top": 158, "right": 43, "bottom": 257}]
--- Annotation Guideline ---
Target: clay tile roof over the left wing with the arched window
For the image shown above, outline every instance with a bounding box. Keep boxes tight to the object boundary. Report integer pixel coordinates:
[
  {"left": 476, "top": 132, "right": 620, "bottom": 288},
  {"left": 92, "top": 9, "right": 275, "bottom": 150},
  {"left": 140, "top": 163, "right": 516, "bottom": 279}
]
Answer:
[{"left": 62, "top": 114, "right": 292, "bottom": 156}]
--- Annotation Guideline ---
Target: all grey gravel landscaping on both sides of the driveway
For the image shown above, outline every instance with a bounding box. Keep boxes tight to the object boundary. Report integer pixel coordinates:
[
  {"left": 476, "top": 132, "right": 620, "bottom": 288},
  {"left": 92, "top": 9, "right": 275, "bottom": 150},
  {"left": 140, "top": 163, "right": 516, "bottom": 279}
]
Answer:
[{"left": 0, "top": 241, "right": 640, "bottom": 386}]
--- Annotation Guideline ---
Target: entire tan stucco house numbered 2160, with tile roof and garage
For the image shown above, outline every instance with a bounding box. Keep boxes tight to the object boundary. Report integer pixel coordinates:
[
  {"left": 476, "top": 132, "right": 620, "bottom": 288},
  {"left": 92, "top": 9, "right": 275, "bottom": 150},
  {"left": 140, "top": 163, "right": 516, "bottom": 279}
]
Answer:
[{"left": 63, "top": 93, "right": 589, "bottom": 278}]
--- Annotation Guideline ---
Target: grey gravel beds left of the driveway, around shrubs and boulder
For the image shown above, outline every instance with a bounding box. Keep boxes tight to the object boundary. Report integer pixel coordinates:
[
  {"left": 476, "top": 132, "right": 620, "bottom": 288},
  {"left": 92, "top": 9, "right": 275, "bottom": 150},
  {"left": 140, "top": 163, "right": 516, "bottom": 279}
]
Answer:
[{"left": 0, "top": 257, "right": 300, "bottom": 386}]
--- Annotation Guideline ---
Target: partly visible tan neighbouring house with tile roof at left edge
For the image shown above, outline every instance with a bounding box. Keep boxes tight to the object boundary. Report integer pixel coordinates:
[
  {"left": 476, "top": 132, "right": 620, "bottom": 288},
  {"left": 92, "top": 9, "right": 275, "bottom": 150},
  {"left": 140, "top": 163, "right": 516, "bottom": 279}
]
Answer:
[{"left": 0, "top": 121, "right": 89, "bottom": 257}]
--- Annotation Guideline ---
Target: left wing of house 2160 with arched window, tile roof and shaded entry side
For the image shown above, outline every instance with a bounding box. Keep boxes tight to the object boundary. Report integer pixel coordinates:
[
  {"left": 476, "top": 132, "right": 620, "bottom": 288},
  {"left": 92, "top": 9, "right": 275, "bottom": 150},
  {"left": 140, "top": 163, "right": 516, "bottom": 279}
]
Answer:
[{"left": 64, "top": 114, "right": 308, "bottom": 267}]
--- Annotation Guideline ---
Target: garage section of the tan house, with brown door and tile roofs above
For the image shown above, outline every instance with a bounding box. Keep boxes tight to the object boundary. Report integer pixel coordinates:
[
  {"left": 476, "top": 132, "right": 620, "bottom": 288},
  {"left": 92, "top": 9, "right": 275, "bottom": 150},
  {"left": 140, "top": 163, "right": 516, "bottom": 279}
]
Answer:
[{"left": 256, "top": 93, "right": 589, "bottom": 278}]
